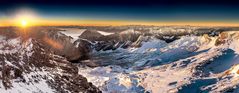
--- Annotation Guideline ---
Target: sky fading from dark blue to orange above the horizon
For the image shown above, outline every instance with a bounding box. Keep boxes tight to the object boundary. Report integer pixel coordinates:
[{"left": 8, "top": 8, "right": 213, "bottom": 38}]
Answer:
[{"left": 0, "top": 0, "right": 239, "bottom": 26}]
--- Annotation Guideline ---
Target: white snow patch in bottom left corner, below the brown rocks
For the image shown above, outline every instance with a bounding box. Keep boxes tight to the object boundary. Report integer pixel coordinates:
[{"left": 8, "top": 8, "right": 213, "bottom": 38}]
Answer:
[{"left": 0, "top": 71, "right": 56, "bottom": 93}]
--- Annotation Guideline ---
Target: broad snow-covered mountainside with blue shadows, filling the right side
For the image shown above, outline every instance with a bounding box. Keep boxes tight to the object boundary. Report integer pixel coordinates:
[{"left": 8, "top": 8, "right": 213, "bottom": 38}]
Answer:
[{"left": 79, "top": 32, "right": 239, "bottom": 93}]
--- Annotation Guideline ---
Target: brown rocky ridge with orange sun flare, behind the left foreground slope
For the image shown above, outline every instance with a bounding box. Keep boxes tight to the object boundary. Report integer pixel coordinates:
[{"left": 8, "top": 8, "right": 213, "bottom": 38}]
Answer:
[{"left": 22, "top": 28, "right": 90, "bottom": 61}]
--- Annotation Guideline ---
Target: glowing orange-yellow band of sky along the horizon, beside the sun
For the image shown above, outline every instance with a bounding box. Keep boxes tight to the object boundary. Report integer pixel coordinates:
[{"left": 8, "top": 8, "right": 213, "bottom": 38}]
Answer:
[{"left": 0, "top": 18, "right": 239, "bottom": 26}]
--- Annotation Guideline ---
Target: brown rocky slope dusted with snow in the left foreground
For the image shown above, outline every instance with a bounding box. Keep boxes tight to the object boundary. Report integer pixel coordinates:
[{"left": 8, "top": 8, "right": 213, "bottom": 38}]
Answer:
[{"left": 0, "top": 30, "right": 100, "bottom": 93}]
